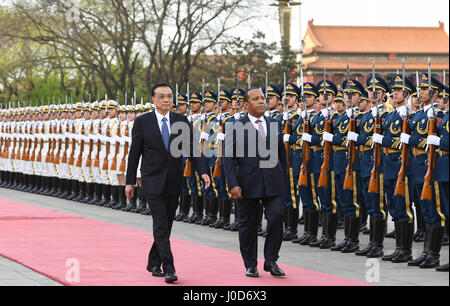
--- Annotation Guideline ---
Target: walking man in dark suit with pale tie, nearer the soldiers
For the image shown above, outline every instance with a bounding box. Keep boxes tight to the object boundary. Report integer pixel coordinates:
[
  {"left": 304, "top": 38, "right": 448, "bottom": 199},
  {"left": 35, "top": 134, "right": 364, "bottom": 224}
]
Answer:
[{"left": 224, "top": 89, "right": 288, "bottom": 277}]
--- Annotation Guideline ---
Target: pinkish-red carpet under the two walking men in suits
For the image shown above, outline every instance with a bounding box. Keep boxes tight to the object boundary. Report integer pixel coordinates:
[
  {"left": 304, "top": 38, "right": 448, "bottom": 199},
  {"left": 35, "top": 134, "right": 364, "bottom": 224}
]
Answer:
[{"left": 0, "top": 199, "right": 367, "bottom": 286}]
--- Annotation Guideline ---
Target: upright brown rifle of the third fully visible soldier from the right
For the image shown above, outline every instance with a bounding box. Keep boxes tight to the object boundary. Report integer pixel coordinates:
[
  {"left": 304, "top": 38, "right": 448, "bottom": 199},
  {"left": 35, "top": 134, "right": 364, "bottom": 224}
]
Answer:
[{"left": 368, "top": 61, "right": 381, "bottom": 193}]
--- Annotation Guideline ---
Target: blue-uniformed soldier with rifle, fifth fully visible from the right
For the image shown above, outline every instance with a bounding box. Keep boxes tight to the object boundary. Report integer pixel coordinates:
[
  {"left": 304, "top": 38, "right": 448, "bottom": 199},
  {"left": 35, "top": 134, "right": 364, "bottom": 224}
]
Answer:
[{"left": 309, "top": 76, "right": 338, "bottom": 249}]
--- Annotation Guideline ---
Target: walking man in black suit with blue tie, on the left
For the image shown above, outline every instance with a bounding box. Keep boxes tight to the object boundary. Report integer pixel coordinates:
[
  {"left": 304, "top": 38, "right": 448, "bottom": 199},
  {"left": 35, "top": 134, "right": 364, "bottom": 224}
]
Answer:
[{"left": 125, "top": 84, "right": 210, "bottom": 283}]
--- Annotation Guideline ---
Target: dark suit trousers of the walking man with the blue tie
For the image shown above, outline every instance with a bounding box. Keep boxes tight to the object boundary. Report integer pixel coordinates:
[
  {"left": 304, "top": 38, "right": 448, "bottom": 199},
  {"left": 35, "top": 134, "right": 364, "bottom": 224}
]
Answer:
[{"left": 145, "top": 189, "right": 179, "bottom": 273}]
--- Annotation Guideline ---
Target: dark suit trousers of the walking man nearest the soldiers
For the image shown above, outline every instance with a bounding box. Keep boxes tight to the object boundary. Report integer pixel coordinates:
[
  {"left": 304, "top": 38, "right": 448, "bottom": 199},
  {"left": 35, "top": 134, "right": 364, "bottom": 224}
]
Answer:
[{"left": 236, "top": 196, "right": 283, "bottom": 268}]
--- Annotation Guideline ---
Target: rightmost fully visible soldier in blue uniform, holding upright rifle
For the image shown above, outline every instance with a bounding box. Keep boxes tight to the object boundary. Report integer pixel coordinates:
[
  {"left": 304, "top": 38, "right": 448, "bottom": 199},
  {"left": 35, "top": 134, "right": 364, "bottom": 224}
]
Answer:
[{"left": 401, "top": 73, "right": 446, "bottom": 268}]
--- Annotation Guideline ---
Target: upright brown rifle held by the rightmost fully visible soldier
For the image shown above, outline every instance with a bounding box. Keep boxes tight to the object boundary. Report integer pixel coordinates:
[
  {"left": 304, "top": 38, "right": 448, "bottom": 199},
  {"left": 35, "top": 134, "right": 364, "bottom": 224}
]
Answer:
[{"left": 420, "top": 58, "right": 436, "bottom": 201}]
